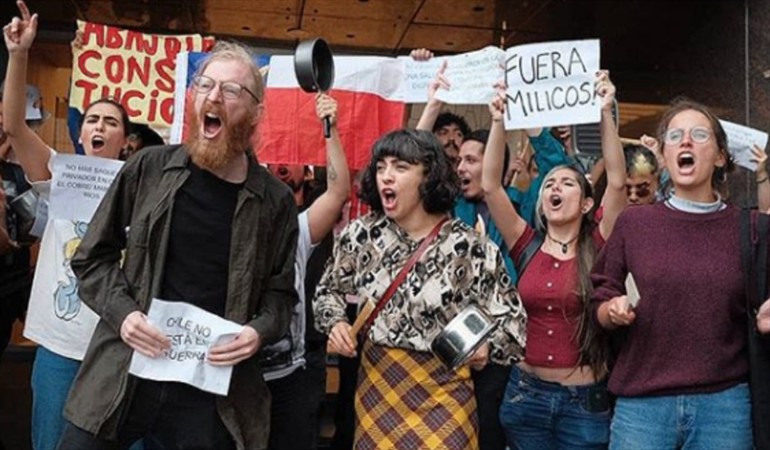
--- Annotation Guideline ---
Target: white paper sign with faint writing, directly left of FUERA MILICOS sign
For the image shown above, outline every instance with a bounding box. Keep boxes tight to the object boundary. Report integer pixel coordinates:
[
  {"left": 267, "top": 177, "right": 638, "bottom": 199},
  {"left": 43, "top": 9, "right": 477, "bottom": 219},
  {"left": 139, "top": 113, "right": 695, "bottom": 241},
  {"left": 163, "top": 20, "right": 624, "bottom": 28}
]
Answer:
[{"left": 436, "top": 47, "right": 505, "bottom": 105}]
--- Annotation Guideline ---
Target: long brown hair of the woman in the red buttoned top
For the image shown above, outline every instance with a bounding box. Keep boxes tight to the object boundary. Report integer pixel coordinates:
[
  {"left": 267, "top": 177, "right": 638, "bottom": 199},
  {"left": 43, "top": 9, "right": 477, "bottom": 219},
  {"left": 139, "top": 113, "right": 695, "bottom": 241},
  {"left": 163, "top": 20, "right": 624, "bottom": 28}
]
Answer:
[{"left": 535, "top": 165, "right": 610, "bottom": 375}]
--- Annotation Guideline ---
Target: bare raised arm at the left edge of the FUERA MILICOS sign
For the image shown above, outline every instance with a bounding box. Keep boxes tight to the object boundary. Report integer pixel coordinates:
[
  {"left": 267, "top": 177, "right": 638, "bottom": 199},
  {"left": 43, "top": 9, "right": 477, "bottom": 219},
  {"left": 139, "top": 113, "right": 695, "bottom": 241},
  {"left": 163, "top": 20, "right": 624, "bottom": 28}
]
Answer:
[{"left": 481, "top": 88, "right": 527, "bottom": 250}]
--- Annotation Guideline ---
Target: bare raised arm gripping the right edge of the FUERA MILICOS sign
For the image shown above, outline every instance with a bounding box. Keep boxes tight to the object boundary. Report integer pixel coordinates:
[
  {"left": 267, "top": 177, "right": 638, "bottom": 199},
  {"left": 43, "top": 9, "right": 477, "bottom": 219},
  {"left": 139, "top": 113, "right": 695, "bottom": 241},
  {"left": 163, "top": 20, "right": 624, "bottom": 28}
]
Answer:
[{"left": 596, "top": 70, "right": 628, "bottom": 239}]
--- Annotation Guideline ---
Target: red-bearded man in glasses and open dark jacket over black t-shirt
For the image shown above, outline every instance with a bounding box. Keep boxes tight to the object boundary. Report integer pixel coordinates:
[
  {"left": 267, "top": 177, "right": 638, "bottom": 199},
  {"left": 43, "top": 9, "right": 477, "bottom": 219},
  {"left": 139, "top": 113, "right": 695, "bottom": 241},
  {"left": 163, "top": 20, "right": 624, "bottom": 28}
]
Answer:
[{"left": 59, "top": 43, "right": 297, "bottom": 449}]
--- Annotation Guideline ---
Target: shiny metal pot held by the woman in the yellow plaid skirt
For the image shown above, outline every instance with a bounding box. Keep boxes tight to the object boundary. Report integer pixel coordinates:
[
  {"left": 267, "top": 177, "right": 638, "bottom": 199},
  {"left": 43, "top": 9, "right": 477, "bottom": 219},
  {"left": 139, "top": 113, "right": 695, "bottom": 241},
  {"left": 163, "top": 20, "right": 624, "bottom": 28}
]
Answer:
[{"left": 430, "top": 305, "right": 495, "bottom": 370}]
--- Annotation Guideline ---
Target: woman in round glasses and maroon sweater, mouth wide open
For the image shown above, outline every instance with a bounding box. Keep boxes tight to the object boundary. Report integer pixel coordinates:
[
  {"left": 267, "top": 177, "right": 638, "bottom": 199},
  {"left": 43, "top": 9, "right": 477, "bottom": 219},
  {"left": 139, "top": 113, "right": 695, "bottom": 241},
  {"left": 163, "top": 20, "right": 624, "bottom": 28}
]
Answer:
[{"left": 593, "top": 101, "right": 752, "bottom": 450}]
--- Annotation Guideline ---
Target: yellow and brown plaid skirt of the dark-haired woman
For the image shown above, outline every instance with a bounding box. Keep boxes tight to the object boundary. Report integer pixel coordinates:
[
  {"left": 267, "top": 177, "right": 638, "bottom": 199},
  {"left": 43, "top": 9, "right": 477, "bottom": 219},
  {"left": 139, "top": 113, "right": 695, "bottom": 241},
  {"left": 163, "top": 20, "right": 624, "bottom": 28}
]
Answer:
[{"left": 354, "top": 341, "right": 478, "bottom": 450}]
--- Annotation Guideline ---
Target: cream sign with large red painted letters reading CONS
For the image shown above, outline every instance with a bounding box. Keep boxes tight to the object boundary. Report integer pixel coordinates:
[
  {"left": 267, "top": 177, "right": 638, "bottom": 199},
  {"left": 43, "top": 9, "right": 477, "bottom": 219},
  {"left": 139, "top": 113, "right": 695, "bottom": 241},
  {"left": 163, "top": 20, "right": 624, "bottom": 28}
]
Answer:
[{"left": 70, "top": 20, "right": 214, "bottom": 128}]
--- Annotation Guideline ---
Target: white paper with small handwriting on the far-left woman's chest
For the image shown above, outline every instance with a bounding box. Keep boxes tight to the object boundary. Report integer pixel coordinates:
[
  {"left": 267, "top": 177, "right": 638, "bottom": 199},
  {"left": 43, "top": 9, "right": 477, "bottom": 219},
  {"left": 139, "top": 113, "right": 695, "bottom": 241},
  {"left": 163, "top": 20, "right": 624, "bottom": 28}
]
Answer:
[{"left": 48, "top": 153, "right": 123, "bottom": 222}]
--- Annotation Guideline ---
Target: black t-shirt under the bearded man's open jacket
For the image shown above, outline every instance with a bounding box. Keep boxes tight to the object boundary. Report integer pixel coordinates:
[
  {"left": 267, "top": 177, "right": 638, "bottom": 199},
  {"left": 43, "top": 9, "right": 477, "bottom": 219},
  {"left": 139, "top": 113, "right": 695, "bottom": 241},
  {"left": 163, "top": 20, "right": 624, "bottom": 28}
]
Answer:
[{"left": 161, "top": 163, "right": 238, "bottom": 316}]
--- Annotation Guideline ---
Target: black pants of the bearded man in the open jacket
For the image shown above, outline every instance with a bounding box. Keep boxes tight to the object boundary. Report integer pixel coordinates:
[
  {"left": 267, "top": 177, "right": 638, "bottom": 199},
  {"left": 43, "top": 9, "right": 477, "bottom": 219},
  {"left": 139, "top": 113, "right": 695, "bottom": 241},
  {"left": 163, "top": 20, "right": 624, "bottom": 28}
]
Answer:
[{"left": 57, "top": 380, "right": 235, "bottom": 450}]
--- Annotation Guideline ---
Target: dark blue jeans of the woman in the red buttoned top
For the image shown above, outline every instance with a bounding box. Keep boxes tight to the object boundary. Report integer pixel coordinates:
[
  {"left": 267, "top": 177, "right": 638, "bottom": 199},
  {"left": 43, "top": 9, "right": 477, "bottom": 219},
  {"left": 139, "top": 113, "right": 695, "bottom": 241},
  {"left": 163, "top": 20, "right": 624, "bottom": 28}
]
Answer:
[{"left": 500, "top": 366, "right": 612, "bottom": 450}]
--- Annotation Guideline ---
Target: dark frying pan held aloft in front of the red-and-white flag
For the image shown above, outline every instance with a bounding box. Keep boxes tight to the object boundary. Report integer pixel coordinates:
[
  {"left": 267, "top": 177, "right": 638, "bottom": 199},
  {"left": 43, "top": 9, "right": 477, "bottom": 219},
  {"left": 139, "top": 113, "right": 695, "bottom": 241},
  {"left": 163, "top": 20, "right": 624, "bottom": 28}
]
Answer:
[{"left": 294, "top": 39, "right": 334, "bottom": 138}]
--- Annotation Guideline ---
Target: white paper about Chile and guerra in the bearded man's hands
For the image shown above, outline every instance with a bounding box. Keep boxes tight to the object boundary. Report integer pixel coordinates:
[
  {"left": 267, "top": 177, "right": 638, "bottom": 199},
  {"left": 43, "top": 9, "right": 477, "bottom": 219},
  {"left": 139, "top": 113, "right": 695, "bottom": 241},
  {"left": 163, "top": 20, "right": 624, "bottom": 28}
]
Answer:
[{"left": 128, "top": 298, "right": 243, "bottom": 395}]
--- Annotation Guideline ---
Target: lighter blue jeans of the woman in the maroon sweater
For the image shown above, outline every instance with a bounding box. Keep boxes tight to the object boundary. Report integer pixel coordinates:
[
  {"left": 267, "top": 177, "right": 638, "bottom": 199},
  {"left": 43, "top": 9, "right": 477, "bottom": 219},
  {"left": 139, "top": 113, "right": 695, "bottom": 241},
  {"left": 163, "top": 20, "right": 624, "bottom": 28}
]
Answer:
[{"left": 610, "top": 383, "right": 753, "bottom": 450}]
